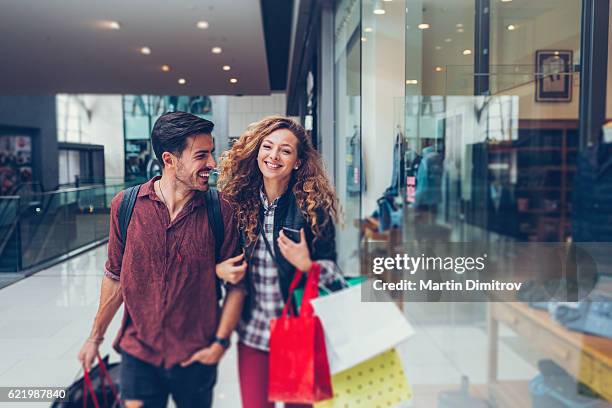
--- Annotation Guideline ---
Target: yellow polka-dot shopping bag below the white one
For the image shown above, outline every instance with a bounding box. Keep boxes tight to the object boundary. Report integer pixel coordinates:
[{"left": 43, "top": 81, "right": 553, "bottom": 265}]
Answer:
[{"left": 314, "top": 349, "right": 412, "bottom": 408}]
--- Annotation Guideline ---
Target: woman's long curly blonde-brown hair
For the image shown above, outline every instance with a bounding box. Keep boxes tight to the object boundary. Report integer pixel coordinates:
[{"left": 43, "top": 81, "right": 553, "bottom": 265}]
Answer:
[{"left": 217, "top": 116, "right": 339, "bottom": 245}]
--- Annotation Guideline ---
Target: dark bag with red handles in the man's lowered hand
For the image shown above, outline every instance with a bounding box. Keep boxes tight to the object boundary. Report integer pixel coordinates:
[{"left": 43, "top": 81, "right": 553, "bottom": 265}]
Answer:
[{"left": 51, "top": 354, "right": 121, "bottom": 408}]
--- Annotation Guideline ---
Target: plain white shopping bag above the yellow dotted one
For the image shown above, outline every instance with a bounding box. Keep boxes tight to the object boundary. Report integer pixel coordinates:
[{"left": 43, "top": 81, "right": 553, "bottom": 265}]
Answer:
[{"left": 311, "top": 285, "right": 414, "bottom": 375}]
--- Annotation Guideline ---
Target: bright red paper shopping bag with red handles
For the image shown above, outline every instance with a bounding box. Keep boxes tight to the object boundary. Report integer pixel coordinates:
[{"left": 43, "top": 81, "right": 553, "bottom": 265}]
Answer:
[{"left": 268, "top": 263, "right": 333, "bottom": 404}]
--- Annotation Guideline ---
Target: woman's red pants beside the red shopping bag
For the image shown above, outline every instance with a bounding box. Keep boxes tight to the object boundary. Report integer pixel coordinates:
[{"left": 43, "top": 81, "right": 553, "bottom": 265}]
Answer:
[{"left": 238, "top": 343, "right": 312, "bottom": 408}]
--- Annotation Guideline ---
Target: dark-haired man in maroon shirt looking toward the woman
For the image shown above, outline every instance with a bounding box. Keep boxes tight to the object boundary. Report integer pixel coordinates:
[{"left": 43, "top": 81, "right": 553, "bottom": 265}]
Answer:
[{"left": 79, "top": 112, "right": 246, "bottom": 408}]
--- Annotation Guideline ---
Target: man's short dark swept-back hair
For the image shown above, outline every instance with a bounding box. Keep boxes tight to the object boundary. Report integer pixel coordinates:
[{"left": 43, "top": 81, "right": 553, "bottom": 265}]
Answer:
[{"left": 151, "top": 112, "right": 215, "bottom": 166}]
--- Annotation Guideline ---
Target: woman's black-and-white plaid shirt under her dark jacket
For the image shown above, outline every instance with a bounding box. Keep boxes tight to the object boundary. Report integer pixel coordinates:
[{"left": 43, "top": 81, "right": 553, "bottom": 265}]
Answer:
[{"left": 237, "top": 190, "right": 341, "bottom": 351}]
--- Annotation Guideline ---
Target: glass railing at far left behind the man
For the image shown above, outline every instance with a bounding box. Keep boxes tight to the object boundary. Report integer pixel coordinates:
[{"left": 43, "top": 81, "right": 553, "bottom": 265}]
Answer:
[{"left": 0, "top": 183, "right": 139, "bottom": 272}]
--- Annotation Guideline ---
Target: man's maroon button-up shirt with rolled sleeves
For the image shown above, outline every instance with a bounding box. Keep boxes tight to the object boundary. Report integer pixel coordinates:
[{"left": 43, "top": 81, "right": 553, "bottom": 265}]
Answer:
[{"left": 105, "top": 177, "right": 244, "bottom": 368}]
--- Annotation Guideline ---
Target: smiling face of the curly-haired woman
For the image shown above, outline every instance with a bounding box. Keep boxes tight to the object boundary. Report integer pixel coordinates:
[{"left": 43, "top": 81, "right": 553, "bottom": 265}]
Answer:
[{"left": 257, "top": 129, "right": 299, "bottom": 183}]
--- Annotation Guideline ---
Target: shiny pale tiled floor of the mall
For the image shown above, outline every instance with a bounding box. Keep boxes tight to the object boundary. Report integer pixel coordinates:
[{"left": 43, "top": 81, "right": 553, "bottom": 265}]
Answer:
[{"left": 0, "top": 246, "right": 537, "bottom": 408}]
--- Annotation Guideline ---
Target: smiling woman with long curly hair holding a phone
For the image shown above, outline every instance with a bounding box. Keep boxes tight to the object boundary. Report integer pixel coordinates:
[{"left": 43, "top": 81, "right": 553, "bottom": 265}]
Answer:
[{"left": 217, "top": 116, "right": 340, "bottom": 408}]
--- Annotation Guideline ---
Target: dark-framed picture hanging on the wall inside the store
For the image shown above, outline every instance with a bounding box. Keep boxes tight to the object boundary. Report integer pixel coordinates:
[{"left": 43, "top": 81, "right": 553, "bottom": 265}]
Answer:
[{"left": 535, "top": 50, "right": 573, "bottom": 102}]
